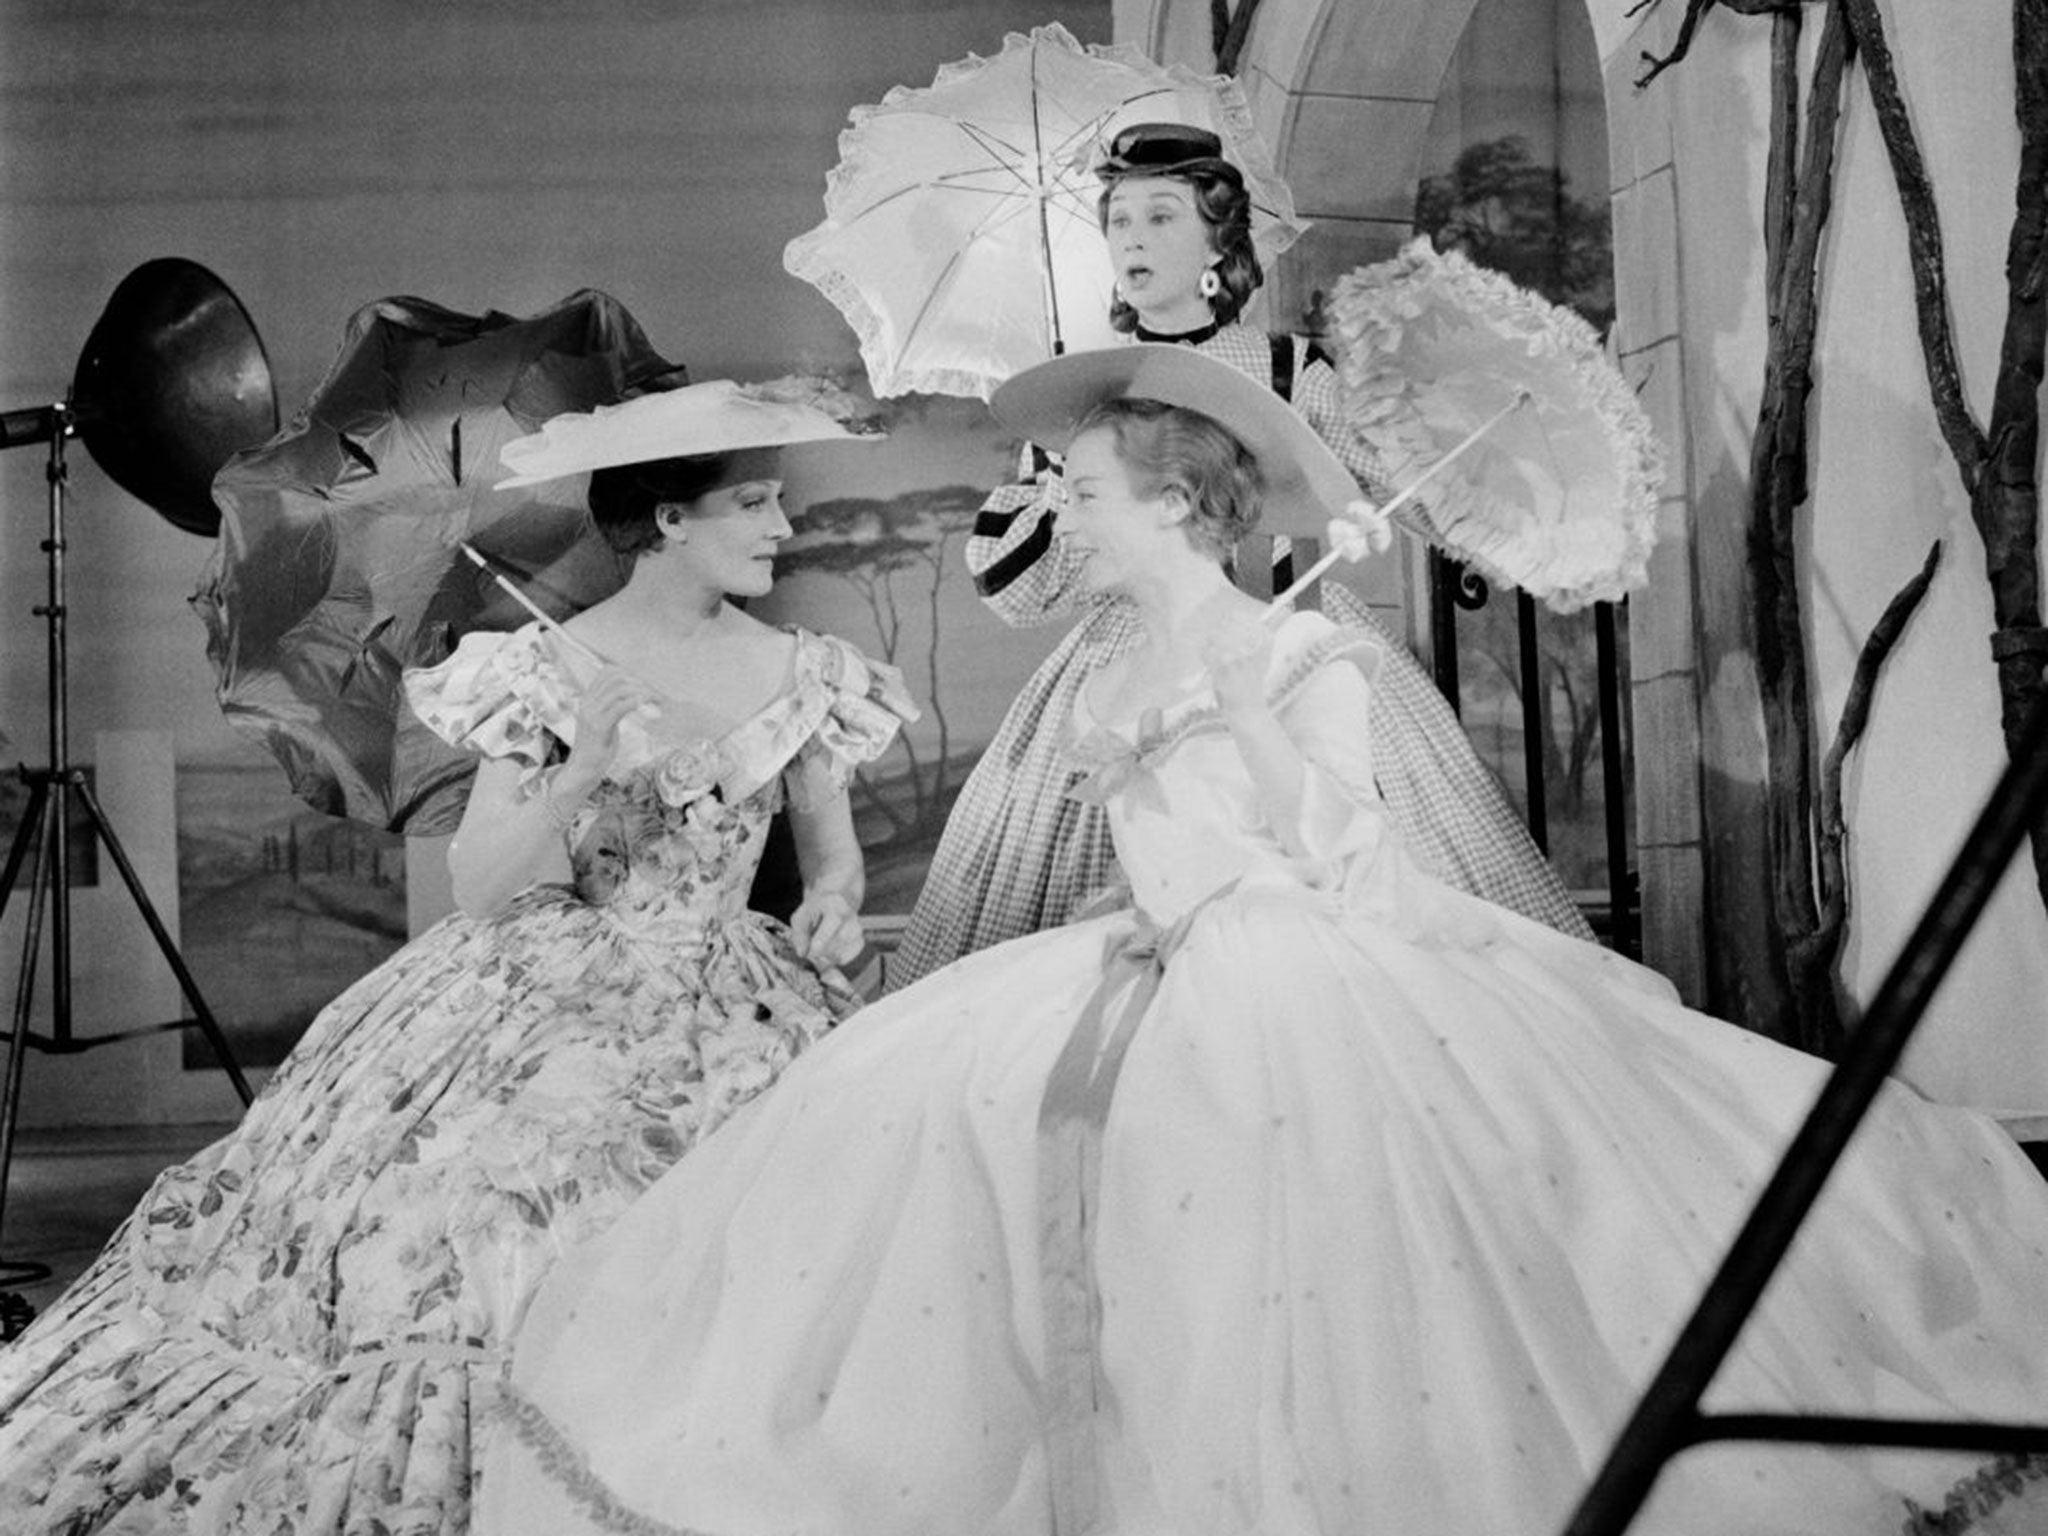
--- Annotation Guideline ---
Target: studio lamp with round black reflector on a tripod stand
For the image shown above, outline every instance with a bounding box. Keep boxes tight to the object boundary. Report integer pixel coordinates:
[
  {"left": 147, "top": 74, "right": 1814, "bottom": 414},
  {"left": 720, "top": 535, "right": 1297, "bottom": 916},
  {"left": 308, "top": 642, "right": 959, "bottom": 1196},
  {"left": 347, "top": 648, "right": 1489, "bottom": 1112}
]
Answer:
[{"left": 0, "top": 260, "right": 276, "bottom": 1337}]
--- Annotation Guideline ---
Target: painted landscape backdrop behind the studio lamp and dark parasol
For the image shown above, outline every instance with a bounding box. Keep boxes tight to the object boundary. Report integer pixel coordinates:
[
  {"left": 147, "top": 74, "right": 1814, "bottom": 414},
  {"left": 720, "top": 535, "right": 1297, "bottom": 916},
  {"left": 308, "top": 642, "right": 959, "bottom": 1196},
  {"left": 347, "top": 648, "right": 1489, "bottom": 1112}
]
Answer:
[{"left": 0, "top": 0, "right": 1110, "bottom": 1118}]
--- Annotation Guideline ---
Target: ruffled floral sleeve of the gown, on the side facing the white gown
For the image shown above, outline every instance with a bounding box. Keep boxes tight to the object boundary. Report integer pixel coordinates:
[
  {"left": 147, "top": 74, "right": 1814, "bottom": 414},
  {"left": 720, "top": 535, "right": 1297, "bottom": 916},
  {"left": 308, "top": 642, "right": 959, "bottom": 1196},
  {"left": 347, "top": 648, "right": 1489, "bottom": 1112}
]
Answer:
[{"left": 721, "top": 629, "right": 920, "bottom": 809}]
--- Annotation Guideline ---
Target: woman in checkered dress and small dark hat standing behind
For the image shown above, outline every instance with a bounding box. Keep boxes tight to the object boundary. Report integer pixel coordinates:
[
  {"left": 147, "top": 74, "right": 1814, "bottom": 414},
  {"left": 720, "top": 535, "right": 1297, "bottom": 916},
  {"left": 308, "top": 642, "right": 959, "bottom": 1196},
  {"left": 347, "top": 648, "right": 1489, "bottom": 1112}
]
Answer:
[{"left": 889, "top": 123, "right": 1591, "bottom": 987}]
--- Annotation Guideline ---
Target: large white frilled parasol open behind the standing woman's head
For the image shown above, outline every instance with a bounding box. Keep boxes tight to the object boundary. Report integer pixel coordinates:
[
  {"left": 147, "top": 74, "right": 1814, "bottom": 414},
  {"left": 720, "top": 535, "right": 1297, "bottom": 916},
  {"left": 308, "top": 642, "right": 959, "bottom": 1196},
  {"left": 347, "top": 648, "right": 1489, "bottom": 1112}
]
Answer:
[{"left": 782, "top": 23, "right": 1303, "bottom": 399}]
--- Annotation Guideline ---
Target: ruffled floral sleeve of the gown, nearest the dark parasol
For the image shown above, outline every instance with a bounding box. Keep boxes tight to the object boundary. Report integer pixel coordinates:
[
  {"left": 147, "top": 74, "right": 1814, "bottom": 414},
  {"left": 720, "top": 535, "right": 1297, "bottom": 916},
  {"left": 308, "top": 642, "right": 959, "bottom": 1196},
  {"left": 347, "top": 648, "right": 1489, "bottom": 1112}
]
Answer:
[{"left": 406, "top": 625, "right": 575, "bottom": 770}]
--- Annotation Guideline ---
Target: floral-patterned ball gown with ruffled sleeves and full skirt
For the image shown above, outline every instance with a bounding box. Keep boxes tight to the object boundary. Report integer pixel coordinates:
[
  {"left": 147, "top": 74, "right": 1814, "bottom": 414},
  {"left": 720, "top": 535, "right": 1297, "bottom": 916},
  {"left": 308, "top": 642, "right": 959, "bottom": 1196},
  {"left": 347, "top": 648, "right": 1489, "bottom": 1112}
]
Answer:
[{"left": 0, "top": 627, "right": 915, "bottom": 1536}]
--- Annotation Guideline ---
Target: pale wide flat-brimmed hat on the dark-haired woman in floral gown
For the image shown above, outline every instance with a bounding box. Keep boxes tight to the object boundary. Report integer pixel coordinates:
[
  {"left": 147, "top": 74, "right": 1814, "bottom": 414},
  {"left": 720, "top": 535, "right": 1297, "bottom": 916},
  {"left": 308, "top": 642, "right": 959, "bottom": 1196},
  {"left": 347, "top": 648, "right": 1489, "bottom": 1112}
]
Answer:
[{"left": 498, "top": 379, "right": 881, "bottom": 489}]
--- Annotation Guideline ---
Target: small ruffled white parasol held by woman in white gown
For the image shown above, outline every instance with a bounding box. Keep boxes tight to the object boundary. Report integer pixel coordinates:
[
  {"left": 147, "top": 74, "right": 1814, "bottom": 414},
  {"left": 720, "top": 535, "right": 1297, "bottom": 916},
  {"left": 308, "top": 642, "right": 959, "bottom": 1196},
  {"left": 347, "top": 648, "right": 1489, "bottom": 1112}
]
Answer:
[{"left": 1329, "top": 240, "right": 1663, "bottom": 612}]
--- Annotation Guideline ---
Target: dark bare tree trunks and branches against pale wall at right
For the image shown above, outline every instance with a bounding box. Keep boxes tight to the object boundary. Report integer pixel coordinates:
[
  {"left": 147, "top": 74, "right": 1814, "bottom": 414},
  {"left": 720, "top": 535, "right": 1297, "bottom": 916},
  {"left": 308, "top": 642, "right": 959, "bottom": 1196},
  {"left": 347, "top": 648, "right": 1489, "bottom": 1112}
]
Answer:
[{"left": 1636, "top": 0, "right": 2048, "bottom": 1053}]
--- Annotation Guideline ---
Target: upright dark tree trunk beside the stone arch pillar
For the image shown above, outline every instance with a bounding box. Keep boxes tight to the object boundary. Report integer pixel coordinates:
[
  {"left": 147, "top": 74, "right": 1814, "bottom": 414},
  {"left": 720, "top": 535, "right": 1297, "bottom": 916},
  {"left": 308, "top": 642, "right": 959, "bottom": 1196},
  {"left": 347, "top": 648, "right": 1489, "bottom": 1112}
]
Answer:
[{"left": 1749, "top": 4, "right": 1851, "bottom": 1055}]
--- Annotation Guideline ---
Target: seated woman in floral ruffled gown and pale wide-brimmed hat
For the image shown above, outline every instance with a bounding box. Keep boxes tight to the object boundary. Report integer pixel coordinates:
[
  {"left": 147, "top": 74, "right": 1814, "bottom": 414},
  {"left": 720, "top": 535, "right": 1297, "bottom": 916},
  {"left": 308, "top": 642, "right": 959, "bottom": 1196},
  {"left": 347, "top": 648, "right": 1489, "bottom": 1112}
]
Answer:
[{"left": 0, "top": 385, "right": 915, "bottom": 1536}]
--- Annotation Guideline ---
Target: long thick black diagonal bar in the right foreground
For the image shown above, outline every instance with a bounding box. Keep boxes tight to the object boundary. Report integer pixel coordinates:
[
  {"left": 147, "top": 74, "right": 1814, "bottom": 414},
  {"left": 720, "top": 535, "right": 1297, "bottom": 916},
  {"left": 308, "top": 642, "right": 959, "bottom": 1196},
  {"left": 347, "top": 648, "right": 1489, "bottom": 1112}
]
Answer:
[{"left": 1565, "top": 684, "right": 2048, "bottom": 1536}]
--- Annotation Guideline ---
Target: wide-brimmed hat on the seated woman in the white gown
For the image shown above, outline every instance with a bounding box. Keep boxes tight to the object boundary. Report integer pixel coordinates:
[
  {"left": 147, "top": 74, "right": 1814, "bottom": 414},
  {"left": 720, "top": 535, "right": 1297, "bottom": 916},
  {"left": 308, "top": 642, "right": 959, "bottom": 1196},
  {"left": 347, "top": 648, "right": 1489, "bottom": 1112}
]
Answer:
[{"left": 989, "top": 342, "right": 1360, "bottom": 539}]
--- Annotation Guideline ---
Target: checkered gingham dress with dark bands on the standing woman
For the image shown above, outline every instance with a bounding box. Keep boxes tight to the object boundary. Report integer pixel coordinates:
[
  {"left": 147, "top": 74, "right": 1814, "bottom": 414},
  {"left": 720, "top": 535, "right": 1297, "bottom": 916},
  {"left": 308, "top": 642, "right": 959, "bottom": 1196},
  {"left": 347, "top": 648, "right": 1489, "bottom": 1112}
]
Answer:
[{"left": 889, "top": 326, "right": 1593, "bottom": 989}]
